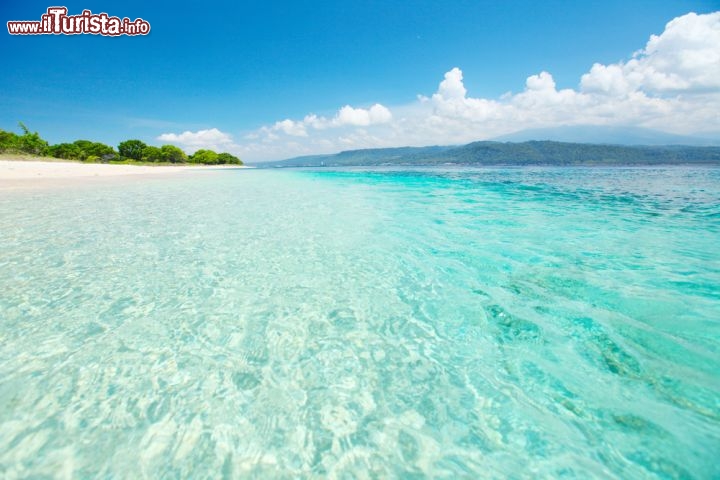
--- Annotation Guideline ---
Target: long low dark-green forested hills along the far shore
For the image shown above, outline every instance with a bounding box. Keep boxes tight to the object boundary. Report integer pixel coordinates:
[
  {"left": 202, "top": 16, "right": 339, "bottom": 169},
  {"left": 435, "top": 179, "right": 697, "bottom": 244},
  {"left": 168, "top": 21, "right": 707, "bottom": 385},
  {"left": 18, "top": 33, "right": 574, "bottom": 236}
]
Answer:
[{"left": 256, "top": 141, "right": 720, "bottom": 167}]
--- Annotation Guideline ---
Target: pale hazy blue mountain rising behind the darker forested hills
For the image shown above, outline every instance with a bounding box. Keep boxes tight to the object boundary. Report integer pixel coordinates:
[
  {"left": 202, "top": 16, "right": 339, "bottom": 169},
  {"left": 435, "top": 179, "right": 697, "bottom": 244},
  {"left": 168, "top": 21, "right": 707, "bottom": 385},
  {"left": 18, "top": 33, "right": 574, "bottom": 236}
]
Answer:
[{"left": 492, "top": 125, "right": 720, "bottom": 146}]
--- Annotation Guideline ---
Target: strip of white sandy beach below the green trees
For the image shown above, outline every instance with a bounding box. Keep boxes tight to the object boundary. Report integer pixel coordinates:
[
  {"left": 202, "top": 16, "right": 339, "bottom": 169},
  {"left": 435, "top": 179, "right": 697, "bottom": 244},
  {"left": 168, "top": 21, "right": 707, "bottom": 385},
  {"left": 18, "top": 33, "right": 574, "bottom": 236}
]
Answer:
[{"left": 0, "top": 159, "right": 247, "bottom": 189}]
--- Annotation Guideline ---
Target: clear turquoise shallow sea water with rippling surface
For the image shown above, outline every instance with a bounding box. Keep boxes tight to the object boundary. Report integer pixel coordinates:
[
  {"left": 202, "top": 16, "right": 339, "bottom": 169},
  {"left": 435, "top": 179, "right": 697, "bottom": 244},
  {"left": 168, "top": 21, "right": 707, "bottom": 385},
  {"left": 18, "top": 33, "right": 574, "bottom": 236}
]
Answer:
[{"left": 0, "top": 168, "right": 720, "bottom": 478}]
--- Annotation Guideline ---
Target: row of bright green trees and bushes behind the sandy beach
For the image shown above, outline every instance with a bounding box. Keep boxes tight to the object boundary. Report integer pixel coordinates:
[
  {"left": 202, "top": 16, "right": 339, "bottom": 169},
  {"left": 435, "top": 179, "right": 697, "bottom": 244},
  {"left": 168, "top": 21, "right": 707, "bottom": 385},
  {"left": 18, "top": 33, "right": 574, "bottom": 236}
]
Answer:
[{"left": 0, "top": 122, "right": 242, "bottom": 165}]
